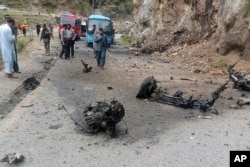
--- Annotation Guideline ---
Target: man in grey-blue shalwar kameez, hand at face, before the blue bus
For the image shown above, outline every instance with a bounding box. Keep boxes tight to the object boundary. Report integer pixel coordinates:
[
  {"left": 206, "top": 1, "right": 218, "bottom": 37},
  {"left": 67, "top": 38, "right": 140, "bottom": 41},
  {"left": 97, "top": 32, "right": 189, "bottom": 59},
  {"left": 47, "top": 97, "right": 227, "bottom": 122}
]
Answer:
[{"left": 94, "top": 28, "right": 108, "bottom": 69}]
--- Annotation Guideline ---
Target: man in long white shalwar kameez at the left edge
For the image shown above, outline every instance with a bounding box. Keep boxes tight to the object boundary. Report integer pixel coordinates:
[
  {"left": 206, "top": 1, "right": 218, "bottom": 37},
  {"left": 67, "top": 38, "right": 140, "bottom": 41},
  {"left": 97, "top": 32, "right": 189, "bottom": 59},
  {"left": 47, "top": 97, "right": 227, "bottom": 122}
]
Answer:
[{"left": 0, "top": 18, "right": 16, "bottom": 78}]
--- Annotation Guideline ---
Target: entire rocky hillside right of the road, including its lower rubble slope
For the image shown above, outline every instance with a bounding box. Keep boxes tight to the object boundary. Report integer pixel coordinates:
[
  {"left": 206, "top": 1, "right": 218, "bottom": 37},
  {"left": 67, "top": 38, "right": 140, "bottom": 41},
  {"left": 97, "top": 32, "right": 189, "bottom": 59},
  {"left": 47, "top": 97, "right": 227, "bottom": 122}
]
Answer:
[{"left": 130, "top": 0, "right": 250, "bottom": 71}]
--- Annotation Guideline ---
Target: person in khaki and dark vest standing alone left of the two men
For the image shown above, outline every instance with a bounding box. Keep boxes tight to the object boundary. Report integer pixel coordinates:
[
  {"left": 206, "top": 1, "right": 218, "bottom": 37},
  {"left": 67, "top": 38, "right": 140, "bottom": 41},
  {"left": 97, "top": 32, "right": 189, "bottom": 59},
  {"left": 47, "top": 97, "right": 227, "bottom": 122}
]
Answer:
[{"left": 40, "top": 24, "right": 54, "bottom": 56}]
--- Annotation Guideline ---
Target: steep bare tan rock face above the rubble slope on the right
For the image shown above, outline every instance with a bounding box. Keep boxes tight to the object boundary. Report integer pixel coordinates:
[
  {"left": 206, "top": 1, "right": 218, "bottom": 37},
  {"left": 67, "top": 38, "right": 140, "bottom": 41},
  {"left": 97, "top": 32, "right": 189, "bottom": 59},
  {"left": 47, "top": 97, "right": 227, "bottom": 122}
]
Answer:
[{"left": 133, "top": 0, "right": 250, "bottom": 54}]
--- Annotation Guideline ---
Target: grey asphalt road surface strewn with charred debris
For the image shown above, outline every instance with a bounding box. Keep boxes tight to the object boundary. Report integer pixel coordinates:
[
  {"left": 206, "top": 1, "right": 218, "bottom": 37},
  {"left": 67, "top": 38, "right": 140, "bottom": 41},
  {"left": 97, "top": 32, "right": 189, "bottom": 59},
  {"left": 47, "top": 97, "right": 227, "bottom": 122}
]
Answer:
[{"left": 0, "top": 37, "right": 250, "bottom": 167}]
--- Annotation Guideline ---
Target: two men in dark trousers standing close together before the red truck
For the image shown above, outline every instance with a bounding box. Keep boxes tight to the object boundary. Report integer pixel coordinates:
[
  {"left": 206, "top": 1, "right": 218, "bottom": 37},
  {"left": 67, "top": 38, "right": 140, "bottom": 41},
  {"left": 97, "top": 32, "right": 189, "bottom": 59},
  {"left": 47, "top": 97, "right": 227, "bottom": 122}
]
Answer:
[{"left": 59, "top": 24, "right": 76, "bottom": 60}]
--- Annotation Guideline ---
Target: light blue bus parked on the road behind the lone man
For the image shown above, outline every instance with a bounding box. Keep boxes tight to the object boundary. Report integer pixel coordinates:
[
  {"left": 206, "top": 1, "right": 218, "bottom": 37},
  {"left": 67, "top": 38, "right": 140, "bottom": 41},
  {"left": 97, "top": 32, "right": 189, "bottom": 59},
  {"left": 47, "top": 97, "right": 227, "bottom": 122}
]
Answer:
[{"left": 86, "top": 14, "right": 114, "bottom": 46}]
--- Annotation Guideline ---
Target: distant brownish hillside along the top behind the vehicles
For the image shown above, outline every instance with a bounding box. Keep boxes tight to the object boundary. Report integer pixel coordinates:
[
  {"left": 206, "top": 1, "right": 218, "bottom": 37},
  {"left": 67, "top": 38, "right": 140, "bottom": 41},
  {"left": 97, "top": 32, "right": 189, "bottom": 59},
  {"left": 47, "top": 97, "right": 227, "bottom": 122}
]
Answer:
[{"left": 5, "top": 0, "right": 133, "bottom": 17}]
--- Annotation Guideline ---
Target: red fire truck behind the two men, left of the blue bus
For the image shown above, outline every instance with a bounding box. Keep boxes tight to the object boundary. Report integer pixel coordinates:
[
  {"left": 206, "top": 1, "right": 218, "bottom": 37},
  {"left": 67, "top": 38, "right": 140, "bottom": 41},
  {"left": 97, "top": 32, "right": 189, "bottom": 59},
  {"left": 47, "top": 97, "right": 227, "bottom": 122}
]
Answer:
[{"left": 58, "top": 12, "right": 81, "bottom": 40}]
